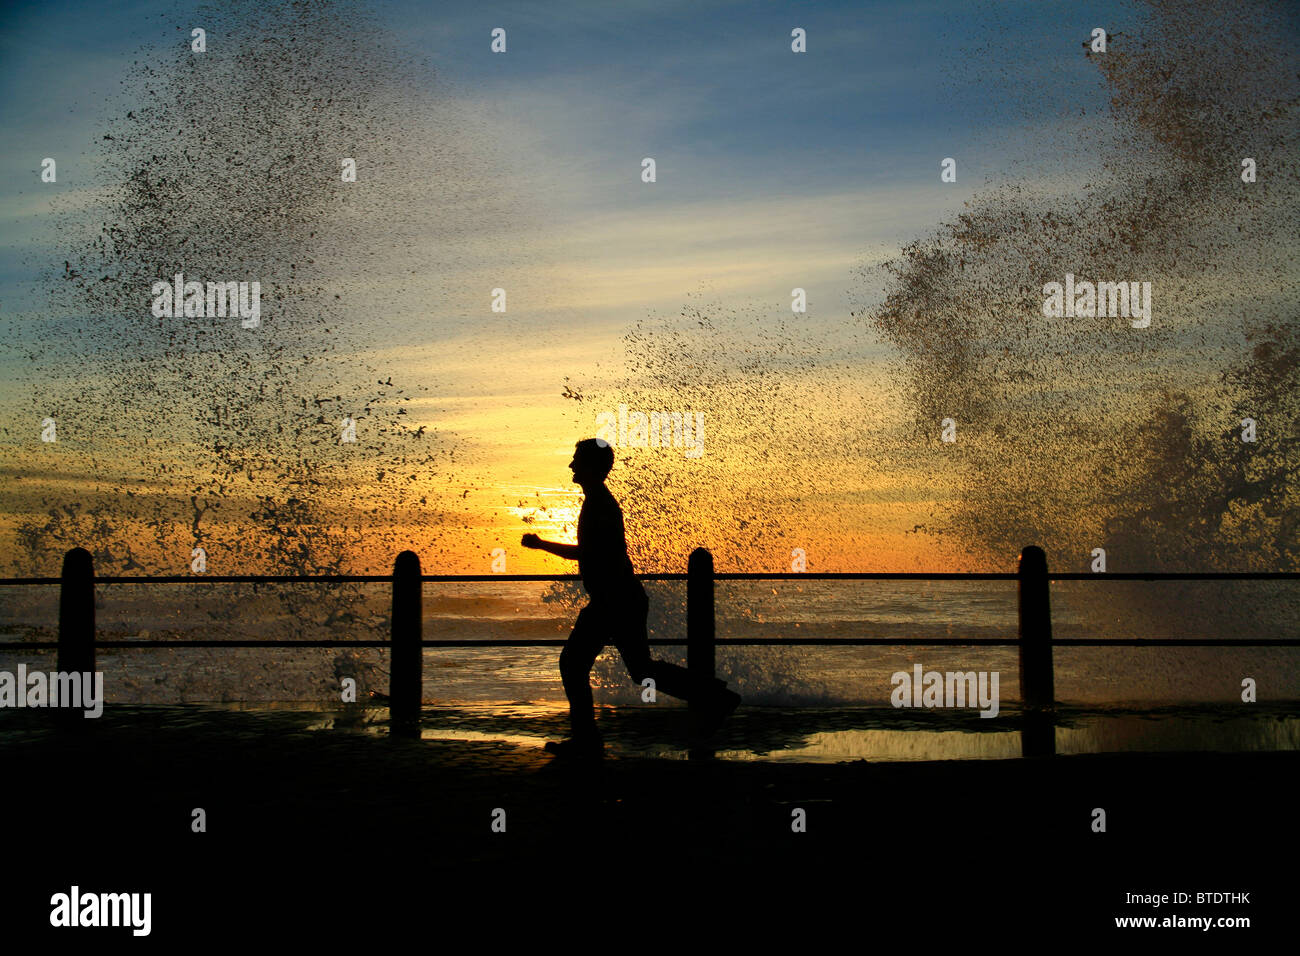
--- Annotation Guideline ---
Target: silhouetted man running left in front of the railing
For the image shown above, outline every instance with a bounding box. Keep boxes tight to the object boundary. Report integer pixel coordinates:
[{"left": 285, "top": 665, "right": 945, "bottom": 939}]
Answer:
[{"left": 521, "top": 438, "right": 740, "bottom": 757}]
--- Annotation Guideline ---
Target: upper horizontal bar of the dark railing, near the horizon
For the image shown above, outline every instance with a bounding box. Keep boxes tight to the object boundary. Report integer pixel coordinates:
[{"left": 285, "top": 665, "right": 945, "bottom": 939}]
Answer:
[{"left": 0, "top": 571, "right": 1300, "bottom": 585}]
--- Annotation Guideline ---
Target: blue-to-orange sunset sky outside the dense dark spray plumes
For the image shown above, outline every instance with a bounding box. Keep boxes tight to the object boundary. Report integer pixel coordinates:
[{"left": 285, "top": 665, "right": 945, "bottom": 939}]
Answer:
[{"left": 0, "top": 0, "right": 1279, "bottom": 574}]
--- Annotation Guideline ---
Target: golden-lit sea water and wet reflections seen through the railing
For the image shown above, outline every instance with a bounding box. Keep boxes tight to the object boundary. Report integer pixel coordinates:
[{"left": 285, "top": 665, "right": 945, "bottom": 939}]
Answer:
[{"left": 0, "top": 580, "right": 1300, "bottom": 761}]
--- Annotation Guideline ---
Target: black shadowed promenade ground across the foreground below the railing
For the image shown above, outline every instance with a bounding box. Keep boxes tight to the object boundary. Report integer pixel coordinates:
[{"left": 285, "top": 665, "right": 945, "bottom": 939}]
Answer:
[{"left": 0, "top": 708, "right": 1300, "bottom": 952}]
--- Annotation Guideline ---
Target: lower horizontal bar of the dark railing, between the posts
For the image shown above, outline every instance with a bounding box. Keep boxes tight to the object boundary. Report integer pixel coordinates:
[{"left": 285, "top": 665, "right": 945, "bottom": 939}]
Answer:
[{"left": 0, "top": 637, "right": 1300, "bottom": 650}]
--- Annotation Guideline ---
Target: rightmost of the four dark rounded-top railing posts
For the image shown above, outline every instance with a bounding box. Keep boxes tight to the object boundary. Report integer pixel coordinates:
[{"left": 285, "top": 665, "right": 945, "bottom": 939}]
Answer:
[{"left": 1017, "top": 545, "right": 1056, "bottom": 757}]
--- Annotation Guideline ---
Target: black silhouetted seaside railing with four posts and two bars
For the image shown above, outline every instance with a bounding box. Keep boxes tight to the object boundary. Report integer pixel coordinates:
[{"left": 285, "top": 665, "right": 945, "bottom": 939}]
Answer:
[{"left": 0, "top": 546, "right": 1300, "bottom": 756}]
